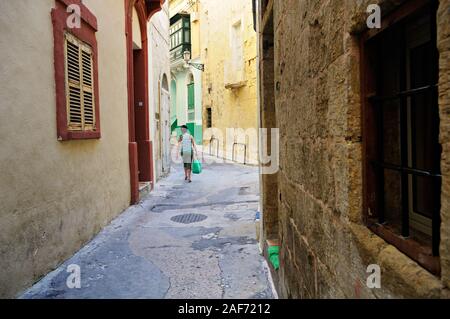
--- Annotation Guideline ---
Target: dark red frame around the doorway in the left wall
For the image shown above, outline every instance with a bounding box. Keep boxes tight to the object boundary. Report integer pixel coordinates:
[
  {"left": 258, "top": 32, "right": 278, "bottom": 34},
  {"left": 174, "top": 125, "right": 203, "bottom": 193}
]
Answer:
[{"left": 124, "top": 0, "right": 165, "bottom": 204}]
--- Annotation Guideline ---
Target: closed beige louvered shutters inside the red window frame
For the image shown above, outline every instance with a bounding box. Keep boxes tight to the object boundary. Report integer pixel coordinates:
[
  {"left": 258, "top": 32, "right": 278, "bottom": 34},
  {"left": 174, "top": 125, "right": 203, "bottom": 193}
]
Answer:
[{"left": 65, "top": 34, "right": 95, "bottom": 131}]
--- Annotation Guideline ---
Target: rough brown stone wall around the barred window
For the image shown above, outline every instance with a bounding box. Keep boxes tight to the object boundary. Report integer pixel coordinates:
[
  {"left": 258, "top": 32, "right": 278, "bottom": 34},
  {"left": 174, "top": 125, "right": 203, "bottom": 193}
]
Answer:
[{"left": 260, "top": 0, "right": 450, "bottom": 298}]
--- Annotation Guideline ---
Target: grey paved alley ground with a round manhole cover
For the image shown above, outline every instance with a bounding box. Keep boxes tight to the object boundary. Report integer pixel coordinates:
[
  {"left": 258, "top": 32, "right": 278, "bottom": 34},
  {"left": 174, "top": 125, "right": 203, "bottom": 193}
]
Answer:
[{"left": 21, "top": 156, "right": 273, "bottom": 299}]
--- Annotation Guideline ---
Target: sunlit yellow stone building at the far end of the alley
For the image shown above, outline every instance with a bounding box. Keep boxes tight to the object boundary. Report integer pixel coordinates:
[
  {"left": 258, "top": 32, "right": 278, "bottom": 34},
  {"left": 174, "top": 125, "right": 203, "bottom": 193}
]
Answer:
[{"left": 199, "top": 0, "right": 258, "bottom": 164}]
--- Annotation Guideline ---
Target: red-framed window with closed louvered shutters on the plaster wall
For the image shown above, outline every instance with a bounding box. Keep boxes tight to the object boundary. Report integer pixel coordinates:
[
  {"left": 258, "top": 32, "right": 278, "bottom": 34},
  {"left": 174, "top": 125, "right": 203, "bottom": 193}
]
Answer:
[{"left": 51, "top": 0, "right": 101, "bottom": 142}]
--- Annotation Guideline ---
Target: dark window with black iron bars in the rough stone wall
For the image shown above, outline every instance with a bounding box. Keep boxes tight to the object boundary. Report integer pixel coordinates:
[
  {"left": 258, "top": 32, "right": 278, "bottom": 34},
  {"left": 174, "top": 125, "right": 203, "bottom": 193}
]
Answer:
[{"left": 362, "top": 0, "right": 442, "bottom": 274}]
